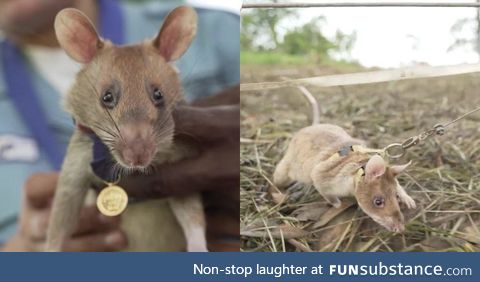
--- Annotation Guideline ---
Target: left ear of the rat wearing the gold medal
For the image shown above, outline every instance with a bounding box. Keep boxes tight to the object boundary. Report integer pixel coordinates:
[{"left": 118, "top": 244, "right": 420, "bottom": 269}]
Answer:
[{"left": 54, "top": 8, "right": 103, "bottom": 64}]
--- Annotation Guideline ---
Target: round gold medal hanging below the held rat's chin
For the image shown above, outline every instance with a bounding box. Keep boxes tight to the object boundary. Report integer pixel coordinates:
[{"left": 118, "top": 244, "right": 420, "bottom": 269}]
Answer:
[{"left": 97, "top": 183, "right": 128, "bottom": 216}]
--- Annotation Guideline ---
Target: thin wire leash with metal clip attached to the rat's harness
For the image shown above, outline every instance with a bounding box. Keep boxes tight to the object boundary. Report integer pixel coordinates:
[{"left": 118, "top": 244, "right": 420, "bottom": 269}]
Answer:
[{"left": 382, "top": 107, "right": 480, "bottom": 159}]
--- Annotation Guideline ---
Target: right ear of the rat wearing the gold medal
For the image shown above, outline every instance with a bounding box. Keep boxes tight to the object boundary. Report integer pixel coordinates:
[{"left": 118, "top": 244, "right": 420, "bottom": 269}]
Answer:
[{"left": 153, "top": 6, "right": 197, "bottom": 62}]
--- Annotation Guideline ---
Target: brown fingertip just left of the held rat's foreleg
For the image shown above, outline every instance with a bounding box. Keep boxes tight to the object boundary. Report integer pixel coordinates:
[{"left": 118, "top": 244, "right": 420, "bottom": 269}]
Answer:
[{"left": 23, "top": 172, "right": 58, "bottom": 208}]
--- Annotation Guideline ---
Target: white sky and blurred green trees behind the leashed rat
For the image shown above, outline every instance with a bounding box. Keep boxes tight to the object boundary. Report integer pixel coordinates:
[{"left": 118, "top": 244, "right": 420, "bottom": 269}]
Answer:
[{"left": 241, "top": 0, "right": 480, "bottom": 68}]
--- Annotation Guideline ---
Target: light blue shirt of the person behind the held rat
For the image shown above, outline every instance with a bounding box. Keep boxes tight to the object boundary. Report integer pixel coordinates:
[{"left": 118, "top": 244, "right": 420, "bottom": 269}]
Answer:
[{"left": 0, "top": 2, "right": 240, "bottom": 242}]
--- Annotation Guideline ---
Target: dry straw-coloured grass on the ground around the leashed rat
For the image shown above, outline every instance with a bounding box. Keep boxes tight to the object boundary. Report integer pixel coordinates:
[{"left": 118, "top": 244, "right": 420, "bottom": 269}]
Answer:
[{"left": 241, "top": 67, "right": 480, "bottom": 251}]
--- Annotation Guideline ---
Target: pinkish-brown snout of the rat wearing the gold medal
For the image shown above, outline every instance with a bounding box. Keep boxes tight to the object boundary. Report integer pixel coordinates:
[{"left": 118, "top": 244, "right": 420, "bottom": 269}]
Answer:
[{"left": 118, "top": 122, "right": 156, "bottom": 167}]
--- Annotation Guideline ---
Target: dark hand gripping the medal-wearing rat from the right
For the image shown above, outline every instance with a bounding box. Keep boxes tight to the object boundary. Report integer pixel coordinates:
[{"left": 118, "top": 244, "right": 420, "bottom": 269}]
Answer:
[{"left": 117, "top": 87, "right": 240, "bottom": 251}]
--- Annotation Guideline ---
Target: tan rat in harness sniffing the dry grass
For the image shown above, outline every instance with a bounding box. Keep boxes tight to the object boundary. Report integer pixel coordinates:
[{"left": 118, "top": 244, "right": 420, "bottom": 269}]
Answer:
[{"left": 273, "top": 93, "right": 416, "bottom": 232}]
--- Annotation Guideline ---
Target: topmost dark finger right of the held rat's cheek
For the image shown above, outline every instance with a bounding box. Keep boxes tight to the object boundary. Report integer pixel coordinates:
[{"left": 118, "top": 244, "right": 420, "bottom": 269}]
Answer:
[{"left": 173, "top": 105, "right": 240, "bottom": 142}]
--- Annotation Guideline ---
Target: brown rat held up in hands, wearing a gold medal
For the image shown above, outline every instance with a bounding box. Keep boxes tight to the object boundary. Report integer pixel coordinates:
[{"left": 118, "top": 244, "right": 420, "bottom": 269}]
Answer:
[{"left": 46, "top": 6, "right": 208, "bottom": 251}]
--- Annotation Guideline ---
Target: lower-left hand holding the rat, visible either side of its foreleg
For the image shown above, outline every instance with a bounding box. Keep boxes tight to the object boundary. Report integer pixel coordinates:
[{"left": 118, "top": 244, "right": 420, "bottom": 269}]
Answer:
[{"left": 2, "top": 173, "right": 127, "bottom": 252}]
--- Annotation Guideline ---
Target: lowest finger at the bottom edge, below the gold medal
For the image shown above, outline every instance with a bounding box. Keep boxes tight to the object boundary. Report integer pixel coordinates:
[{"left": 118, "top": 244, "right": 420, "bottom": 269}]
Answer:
[{"left": 63, "top": 230, "right": 127, "bottom": 252}]
